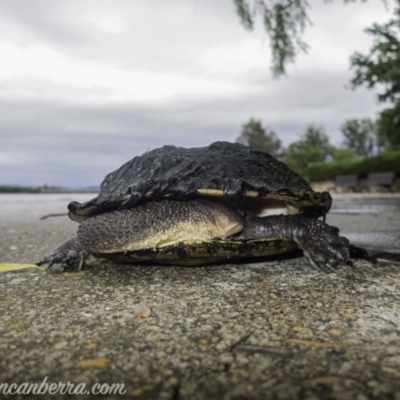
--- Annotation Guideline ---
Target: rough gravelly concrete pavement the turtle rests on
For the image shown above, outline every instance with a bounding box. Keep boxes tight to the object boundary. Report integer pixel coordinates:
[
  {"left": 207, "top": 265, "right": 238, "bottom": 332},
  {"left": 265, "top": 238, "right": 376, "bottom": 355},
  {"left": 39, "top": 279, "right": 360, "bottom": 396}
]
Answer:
[{"left": 0, "top": 195, "right": 400, "bottom": 400}]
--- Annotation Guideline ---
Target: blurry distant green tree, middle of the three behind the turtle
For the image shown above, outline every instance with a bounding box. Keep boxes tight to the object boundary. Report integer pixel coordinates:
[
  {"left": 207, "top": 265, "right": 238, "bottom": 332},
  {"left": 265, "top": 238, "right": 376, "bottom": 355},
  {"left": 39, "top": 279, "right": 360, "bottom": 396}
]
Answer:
[{"left": 285, "top": 125, "right": 332, "bottom": 175}]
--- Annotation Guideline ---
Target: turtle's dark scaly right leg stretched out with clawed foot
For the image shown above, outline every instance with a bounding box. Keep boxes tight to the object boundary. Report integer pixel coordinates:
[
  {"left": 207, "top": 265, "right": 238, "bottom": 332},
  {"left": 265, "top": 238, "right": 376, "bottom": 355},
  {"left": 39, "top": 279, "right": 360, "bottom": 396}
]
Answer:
[{"left": 240, "top": 215, "right": 351, "bottom": 272}]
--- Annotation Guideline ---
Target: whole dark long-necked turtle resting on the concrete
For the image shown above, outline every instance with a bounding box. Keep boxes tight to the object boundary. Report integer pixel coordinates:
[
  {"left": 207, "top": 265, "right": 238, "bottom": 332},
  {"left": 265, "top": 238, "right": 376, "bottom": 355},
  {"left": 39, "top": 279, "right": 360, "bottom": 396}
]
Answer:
[{"left": 38, "top": 141, "right": 350, "bottom": 272}]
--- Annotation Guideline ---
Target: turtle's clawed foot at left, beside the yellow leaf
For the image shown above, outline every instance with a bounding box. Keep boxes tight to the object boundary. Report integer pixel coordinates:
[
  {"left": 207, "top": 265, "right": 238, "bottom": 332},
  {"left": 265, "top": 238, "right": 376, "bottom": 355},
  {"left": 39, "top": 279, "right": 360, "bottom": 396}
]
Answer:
[{"left": 36, "top": 237, "right": 89, "bottom": 272}]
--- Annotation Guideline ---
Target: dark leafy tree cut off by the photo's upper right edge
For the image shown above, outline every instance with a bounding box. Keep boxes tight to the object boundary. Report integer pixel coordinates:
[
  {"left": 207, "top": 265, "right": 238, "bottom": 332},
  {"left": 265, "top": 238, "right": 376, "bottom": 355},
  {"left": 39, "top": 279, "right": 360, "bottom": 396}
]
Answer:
[{"left": 351, "top": 0, "right": 400, "bottom": 146}]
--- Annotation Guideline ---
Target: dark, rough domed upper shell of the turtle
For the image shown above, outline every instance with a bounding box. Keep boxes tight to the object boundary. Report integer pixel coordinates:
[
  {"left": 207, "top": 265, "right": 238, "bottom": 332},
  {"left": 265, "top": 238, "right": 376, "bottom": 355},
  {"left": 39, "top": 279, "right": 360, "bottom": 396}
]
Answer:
[{"left": 68, "top": 142, "right": 332, "bottom": 221}]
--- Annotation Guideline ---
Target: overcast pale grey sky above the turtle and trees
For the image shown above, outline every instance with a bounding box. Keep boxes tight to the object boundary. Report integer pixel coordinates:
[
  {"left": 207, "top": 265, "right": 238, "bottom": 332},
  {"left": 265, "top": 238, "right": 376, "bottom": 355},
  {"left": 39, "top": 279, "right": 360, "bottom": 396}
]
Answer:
[{"left": 0, "top": 0, "right": 393, "bottom": 187}]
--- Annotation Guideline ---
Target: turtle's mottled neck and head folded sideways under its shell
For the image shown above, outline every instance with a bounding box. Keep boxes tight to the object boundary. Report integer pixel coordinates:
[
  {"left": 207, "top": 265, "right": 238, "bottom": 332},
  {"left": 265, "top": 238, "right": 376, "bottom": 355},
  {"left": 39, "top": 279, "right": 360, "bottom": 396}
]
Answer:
[{"left": 78, "top": 200, "right": 243, "bottom": 254}]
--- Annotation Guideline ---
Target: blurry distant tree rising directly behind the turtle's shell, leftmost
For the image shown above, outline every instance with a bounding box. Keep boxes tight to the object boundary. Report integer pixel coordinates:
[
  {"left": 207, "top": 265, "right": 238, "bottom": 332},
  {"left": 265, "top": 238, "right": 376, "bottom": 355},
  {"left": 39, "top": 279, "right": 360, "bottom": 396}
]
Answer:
[{"left": 236, "top": 118, "right": 282, "bottom": 158}]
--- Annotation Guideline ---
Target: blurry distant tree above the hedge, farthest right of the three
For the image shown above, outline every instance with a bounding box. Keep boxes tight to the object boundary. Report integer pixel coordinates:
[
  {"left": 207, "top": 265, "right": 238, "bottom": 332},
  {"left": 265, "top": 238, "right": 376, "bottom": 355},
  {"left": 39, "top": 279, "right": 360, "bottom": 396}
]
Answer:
[{"left": 341, "top": 118, "right": 379, "bottom": 157}]
